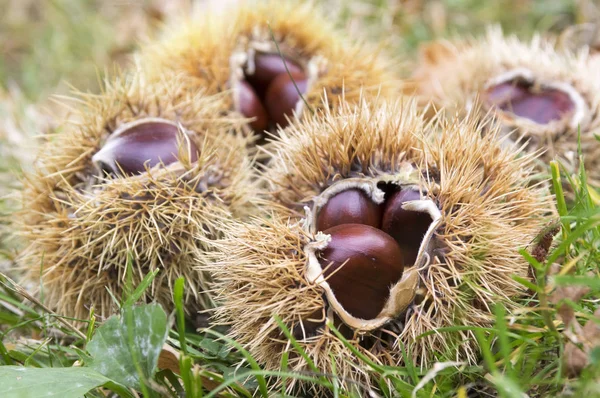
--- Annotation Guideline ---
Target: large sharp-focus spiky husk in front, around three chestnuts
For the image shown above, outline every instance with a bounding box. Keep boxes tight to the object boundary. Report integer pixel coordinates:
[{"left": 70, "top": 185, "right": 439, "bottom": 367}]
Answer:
[{"left": 208, "top": 98, "right": 551, "bottom": 388}]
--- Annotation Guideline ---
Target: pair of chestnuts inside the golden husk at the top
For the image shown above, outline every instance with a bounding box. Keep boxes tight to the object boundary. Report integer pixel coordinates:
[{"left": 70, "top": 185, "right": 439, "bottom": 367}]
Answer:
[{"left": 237, "top": 53, "right": 307, "bottom": 133}]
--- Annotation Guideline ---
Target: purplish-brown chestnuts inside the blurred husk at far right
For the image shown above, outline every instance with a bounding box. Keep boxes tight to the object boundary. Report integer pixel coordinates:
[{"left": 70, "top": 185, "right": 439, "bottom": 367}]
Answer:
[{"left": 484, "top": 79, "right": 575, "bottom": 124}]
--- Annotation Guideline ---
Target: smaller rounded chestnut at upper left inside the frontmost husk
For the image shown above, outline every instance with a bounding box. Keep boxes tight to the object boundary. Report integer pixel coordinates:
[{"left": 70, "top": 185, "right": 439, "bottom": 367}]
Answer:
[{"left": 317, "top": 188, "right": 382, "bottom": 231}]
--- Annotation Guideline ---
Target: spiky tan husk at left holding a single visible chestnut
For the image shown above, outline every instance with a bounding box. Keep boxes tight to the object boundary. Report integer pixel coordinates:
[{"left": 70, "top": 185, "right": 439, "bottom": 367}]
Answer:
[{"left": 15, "top": 73, "right": 257, "bottom": 318}]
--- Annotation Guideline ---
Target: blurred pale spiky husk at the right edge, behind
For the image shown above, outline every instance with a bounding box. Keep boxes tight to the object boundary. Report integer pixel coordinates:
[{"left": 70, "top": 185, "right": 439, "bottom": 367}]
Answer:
[{"left": 414, "top": 29, "right": 600, "bottom": 186}]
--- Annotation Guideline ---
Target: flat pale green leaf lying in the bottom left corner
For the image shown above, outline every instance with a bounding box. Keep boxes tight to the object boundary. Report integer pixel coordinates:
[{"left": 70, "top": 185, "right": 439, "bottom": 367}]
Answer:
[{"left": 0, "top": 366, "right": 130, "bottom": 398}]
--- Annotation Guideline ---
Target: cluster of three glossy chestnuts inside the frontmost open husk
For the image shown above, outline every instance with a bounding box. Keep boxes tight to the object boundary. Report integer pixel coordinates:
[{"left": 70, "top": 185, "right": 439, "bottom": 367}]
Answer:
[{"left": 316, "top": 188, "right": 432, "bottom": 320}]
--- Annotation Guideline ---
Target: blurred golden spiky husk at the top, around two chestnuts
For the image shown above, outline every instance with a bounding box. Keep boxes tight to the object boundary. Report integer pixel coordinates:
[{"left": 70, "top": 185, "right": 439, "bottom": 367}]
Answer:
[{"left": 140, "top": 0, "right": 400, "bottom": 127}]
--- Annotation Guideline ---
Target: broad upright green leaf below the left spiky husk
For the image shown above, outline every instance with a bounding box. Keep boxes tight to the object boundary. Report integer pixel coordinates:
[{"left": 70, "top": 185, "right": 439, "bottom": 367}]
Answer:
[{"left": 87, "top": 304, "right": 168, "bottom": 389}]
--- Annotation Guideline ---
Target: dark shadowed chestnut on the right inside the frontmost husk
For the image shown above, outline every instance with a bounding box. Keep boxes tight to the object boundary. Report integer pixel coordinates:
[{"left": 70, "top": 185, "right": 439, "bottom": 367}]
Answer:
[{"left": 381, "top": 189, "right": 433, "bottom": 265}]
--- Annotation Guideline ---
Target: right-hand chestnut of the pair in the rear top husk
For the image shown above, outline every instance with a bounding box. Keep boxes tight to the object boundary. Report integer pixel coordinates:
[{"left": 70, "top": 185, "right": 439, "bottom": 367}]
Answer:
[{"left": 265, "top": 72, "right": 307, "bottom": 127}]
